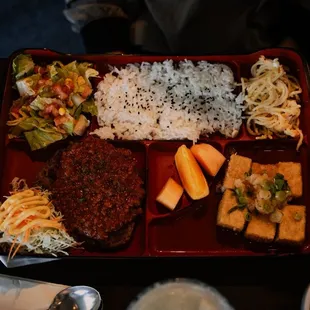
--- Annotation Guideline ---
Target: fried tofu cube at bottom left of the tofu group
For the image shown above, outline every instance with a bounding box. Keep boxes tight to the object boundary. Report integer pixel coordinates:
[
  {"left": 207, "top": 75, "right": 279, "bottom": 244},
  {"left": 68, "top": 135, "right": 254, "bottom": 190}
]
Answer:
[{"left": 217, "top": 189, "right": 246, "bottom": 231}]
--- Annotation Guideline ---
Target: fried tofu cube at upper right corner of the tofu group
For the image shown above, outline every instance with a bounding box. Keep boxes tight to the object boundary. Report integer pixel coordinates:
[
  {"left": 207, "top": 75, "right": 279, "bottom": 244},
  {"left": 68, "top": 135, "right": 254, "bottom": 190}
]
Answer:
[{"left": 277, "top": 162, "right": 302, "bottom": 197}]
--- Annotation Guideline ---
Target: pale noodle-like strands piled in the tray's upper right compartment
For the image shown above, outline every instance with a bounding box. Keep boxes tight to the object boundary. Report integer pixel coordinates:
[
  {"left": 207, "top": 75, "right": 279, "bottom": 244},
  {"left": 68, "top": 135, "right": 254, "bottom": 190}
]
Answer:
[{"left": 241, "top": 56, "right": 303, "bottom": 149}]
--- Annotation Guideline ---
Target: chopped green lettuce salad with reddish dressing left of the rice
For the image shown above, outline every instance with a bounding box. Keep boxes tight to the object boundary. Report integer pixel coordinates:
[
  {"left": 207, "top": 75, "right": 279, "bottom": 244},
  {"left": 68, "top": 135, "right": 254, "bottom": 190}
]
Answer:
[{"left": 7, "top": 54, "right": 99, "bottom": 151}]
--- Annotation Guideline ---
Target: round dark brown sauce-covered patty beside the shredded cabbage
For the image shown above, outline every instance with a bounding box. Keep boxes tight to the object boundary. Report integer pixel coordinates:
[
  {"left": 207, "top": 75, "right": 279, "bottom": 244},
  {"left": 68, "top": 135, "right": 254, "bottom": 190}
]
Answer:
[{"left": 38, "top": 136, "right": 144, "bottom": 248}]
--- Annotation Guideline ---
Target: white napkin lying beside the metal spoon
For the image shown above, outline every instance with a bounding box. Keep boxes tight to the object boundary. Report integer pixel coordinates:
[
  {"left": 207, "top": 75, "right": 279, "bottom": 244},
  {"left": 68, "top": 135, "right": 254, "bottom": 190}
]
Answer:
[{"left": 0, "top": 274, "right": 67, "bottom": 310}]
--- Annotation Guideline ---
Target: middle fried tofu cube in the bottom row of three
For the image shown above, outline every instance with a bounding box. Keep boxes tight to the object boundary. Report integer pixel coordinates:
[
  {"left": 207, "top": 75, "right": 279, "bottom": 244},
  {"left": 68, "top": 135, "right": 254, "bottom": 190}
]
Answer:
[{"left": 244, "top": 214, "right": 276, "bottom": 243}]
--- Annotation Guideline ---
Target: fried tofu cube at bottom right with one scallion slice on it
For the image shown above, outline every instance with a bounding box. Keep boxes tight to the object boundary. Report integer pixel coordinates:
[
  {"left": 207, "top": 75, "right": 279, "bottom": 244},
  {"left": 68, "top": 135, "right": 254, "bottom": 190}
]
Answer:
[{"left": 277, "top": 205, "right": 306, "bottom": 245}]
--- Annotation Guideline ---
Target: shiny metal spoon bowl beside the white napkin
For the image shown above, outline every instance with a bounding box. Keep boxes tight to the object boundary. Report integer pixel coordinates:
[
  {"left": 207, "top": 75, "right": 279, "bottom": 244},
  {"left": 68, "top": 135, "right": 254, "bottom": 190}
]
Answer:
[{"left": 48, "top": 286, "right": 102, "bottom": 310}]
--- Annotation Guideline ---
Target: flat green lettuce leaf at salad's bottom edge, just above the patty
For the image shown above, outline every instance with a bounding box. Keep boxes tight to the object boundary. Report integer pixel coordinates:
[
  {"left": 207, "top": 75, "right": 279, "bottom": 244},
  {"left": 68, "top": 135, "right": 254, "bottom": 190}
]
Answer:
[{"left": 24, "top": 127, "right": 65, "bottom": 151}]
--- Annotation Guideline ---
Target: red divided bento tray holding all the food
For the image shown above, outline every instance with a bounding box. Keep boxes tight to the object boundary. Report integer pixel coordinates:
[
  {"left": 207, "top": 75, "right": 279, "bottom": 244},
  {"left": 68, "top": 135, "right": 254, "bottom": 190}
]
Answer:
[{"left": 0, "top": 49, "right": 310, "bottom": 257}]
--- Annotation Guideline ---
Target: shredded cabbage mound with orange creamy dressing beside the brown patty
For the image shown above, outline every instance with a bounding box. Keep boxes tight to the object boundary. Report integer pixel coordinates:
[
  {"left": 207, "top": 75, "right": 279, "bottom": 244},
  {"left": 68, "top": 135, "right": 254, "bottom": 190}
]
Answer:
[{"left": 0, "top": 178, "right": 78, "bottom": 260}]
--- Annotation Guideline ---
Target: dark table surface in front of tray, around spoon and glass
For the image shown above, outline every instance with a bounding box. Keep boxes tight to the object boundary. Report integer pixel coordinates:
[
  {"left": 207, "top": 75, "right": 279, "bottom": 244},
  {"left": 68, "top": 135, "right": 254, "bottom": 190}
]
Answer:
[{"left": 0, "top": 59, "right": 310, "bottom": 310}]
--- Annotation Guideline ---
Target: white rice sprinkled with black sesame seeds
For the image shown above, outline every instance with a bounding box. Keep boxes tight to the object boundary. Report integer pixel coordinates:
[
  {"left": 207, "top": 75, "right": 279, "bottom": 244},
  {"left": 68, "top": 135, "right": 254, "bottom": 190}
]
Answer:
[{"left": 93, "top": 60, "right": 243, "bottom": 142}]
